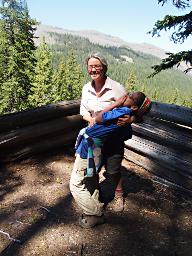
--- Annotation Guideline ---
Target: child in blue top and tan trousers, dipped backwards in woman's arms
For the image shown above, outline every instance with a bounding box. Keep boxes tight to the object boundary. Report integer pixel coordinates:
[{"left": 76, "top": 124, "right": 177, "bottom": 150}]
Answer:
[{"left": 70, "top": 92, "right": 150, "bottom": 228}]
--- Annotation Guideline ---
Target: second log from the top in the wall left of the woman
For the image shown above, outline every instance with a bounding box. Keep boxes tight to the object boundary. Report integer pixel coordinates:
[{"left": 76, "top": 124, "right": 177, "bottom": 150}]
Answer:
[{"left": 0, "top": 115, "right": 84, "bottom": 150}]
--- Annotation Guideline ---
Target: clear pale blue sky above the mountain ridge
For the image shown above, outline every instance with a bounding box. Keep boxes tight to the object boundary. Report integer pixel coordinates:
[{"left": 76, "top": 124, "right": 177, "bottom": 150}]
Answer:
[{"left": 26, "top": 0, "right": 192, "bottom": 52}]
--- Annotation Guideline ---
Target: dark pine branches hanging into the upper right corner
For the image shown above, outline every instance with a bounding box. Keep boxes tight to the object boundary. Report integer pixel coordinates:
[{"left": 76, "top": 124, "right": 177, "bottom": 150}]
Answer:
[{"left": 149, "top": 0, "right": 192, "bottom": 76}]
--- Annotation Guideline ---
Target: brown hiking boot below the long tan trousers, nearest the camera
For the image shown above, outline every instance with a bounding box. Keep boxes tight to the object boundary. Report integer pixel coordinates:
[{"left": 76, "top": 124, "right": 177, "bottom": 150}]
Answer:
[{"left": 79, "top": 214, "right": 105, "bottom": 228}]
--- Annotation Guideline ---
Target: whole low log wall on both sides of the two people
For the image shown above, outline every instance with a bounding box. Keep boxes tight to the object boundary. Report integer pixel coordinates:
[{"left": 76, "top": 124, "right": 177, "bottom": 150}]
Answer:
[{"left": 0, "top": 101, "right": 192, "bottom": 190}]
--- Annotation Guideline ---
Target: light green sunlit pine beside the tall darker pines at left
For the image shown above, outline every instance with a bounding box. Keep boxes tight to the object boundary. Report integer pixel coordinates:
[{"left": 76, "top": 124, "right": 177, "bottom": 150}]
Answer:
[{"left": 29, "top": 42, "right": 53, "bottom": 107}]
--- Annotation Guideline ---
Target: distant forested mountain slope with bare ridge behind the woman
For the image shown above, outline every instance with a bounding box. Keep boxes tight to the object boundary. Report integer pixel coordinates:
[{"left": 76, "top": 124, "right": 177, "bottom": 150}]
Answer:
[{"left": 33, "top": 22, "right": 192, "bottom": 105}]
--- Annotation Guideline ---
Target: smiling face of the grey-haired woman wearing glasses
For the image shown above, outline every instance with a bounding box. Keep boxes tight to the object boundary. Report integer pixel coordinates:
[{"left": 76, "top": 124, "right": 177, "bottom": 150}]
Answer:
[{"left": 87, "top": 58, "right": 104, "bottom": 81}]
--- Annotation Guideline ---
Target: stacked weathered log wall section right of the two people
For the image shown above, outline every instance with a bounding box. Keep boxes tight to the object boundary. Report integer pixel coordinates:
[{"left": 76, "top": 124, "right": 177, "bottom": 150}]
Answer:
[{"left": 125, "top": 102, "right": 192, "bottom": 190}]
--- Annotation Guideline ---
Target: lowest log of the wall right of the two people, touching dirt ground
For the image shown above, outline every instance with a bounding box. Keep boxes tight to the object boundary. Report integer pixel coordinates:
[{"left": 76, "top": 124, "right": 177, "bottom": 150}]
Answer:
[{"left": 124, "top": 148, "right": 192, "bottom": 190}]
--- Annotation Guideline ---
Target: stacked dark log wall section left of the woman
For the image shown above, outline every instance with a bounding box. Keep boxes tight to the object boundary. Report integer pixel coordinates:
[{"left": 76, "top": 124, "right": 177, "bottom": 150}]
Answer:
[{"left": 0, "top": 101, "right": 84, "bottom": 162}]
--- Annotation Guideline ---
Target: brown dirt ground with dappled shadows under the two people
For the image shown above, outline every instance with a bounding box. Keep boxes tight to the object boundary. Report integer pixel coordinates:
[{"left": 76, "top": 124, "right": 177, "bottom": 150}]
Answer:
[{"left": 0, "top": 152, "right": 192, "bottom": 256}]
